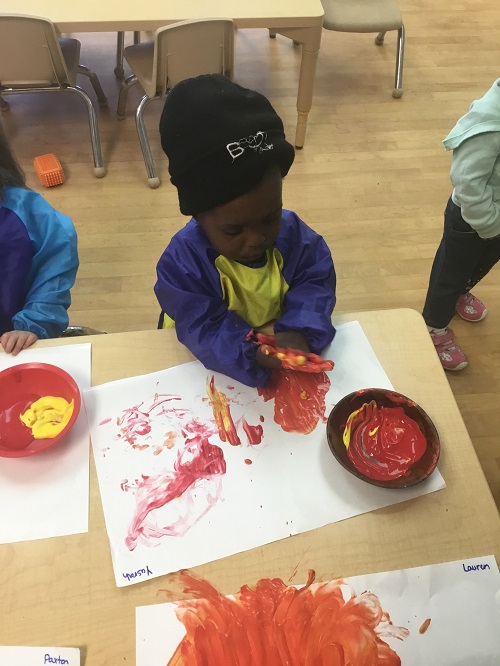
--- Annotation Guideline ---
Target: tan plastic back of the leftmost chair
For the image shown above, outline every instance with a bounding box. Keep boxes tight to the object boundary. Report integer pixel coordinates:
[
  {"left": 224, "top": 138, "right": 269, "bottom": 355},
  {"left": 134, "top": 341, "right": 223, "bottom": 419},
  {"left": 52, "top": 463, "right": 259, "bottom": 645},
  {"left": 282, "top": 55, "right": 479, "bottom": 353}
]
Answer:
[{"left": 0, "top": 14, "right": 69, "bottom": 90}]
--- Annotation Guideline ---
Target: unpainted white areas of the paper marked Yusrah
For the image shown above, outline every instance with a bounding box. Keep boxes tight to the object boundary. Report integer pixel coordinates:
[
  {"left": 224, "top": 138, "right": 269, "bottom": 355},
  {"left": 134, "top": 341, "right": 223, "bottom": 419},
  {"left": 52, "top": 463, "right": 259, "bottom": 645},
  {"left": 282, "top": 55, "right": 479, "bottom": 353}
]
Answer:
[{"left": 84, "top": 322, "right": 444, "bottom": 586}]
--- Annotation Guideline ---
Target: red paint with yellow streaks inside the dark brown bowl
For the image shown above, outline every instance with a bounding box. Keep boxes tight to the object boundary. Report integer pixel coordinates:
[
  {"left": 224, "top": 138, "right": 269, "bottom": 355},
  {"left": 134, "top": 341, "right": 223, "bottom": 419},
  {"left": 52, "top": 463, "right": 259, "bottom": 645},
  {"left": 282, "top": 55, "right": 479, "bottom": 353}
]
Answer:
[{"left": 344, "top": 400, "right": 427, "bottom": 481}]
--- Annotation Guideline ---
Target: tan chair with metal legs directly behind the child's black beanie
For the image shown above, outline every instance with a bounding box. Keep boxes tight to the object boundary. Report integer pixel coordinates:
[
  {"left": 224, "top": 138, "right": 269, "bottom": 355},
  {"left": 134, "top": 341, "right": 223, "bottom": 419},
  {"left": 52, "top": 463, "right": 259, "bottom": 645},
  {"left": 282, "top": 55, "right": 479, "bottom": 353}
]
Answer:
[{"left": 116, "top": 19, "right": 234, "bottom": 188}]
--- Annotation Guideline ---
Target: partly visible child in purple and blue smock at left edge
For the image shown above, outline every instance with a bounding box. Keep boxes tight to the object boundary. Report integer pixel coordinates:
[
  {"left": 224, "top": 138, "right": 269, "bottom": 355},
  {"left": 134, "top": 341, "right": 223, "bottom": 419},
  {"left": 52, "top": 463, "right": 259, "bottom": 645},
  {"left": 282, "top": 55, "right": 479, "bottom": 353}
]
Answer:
[{"left": 0, "top": 128, "right": 78, "bottom": 356}]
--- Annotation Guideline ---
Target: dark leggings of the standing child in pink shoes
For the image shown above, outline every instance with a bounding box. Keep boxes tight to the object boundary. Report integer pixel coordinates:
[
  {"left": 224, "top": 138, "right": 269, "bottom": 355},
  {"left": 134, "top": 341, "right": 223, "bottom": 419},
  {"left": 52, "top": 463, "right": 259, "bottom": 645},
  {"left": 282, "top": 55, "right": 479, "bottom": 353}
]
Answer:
[{"left": 423, "top": 198, "right": 500, "bottom": 328}]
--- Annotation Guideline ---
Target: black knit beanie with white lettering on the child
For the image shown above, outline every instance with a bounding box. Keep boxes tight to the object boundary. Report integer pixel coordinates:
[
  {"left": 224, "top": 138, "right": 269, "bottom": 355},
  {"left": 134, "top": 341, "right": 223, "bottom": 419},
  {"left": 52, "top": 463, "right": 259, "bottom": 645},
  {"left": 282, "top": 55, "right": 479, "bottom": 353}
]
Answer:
[{"left": 160, "top": 74, "right": 295, "bottom": 215}]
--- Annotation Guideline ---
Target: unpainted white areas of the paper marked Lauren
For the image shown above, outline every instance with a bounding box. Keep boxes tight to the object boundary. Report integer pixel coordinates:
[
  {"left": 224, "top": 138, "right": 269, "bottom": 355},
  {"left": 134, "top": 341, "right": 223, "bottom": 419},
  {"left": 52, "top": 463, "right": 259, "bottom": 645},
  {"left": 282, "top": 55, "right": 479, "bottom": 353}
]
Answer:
[{"left": 136, "top": 556, "right": 500, "bottom": 666}]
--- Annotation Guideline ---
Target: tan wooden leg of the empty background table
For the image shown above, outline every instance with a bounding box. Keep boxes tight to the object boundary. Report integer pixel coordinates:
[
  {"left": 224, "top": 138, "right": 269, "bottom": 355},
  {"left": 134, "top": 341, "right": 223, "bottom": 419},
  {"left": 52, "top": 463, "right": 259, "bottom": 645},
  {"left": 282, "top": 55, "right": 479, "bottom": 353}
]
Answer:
[{"left": 273, "top": 25, "right": 323, "bottom": 149}]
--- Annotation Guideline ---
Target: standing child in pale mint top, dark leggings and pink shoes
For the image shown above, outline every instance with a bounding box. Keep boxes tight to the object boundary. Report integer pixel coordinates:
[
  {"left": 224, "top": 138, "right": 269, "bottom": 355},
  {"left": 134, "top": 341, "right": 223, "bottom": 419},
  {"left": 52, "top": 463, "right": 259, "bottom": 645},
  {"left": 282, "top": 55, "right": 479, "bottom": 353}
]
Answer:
[{"left": 423, "top": 79, "right": 500, "bottom": 370}]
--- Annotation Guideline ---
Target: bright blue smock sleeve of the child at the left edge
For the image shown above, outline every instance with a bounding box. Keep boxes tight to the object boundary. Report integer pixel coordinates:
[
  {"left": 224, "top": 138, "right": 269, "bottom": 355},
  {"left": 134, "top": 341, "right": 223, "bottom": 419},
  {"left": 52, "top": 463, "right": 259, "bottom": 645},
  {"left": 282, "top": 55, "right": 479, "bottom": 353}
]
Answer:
[{"left": 12, "top": 192, "right": 79, "bottom": 338}]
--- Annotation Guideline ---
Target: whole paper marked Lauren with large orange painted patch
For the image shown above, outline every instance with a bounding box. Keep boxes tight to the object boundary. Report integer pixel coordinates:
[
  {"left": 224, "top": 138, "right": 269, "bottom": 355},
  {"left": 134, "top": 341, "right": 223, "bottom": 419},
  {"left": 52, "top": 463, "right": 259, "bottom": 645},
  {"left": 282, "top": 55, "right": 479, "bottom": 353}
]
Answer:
[{"left": 136, "top": 555, "right": 500, "bottom": 666}]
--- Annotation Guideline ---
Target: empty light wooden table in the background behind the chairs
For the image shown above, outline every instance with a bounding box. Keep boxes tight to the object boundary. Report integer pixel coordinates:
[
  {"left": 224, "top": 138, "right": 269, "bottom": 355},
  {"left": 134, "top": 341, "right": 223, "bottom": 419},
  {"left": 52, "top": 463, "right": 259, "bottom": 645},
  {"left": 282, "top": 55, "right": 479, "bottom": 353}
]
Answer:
[{"left": 9, "top": 0, "right": 324, "bottom": 148}]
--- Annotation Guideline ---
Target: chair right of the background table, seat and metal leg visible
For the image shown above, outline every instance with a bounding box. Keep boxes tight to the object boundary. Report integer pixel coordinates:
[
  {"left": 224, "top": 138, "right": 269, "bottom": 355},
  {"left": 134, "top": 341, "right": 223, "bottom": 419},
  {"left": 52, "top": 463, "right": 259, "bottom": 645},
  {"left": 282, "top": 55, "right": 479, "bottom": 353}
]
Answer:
[{"left": 321, "top": 0, "right": 405, "bottom": 98}]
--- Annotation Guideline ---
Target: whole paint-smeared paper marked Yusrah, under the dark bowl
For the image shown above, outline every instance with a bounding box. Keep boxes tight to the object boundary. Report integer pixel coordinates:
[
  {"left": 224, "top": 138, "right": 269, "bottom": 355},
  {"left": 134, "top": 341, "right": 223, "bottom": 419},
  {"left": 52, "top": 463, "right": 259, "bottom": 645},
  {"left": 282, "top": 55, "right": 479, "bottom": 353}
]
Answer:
[{"left": 84, "top": 323, "right": 444, "bottom": 586}]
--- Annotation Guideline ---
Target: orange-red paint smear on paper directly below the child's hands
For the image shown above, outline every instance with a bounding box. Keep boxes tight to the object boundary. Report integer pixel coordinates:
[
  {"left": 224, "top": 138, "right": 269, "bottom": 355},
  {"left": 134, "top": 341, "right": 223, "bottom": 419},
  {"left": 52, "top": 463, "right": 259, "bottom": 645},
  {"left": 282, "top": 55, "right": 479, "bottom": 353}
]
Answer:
[{"left": 258, "top": 370, "right": 330, "bottom": 435}]
